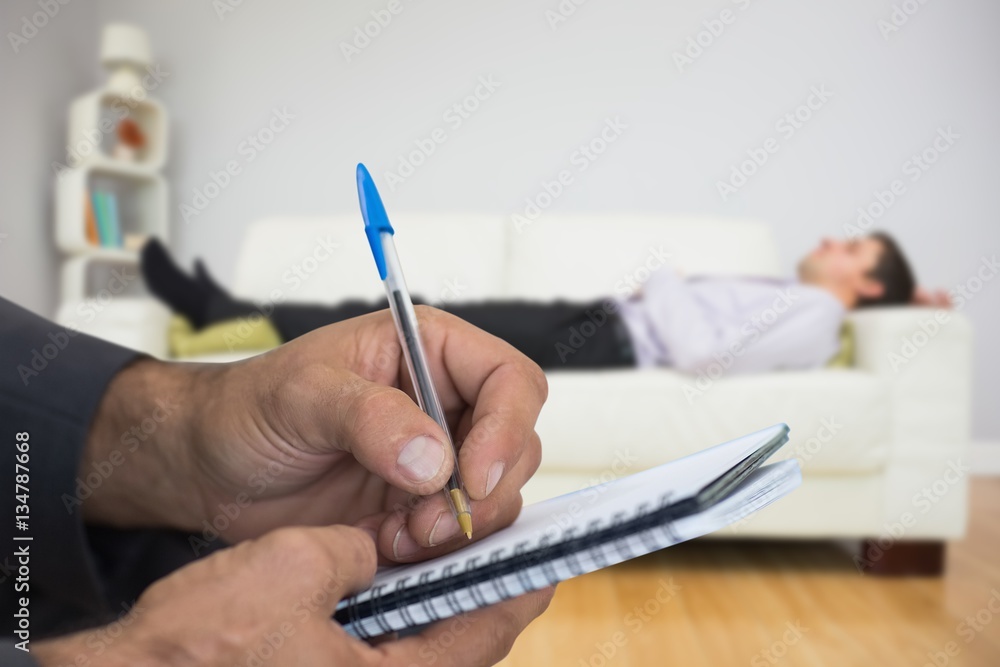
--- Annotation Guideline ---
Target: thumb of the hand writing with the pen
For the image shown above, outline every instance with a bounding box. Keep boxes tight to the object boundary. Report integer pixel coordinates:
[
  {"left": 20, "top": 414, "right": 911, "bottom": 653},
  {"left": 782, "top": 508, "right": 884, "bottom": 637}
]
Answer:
[{"left": 296, "top": 369, "right": 454, "bottom": 496}]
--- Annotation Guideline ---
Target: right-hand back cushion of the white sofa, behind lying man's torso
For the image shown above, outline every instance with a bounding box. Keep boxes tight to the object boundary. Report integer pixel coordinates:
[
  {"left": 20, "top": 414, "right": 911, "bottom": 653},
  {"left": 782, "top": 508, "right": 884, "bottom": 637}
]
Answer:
[{"left": 507, "top": 215, "right": 781, "bottom": 299}]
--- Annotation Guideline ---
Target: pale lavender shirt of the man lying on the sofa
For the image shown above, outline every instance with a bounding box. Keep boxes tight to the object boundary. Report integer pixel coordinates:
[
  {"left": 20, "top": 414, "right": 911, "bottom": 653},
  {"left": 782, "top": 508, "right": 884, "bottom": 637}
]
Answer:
[{"left": 619, "top": 268, "right": 846, "bottom": 373}]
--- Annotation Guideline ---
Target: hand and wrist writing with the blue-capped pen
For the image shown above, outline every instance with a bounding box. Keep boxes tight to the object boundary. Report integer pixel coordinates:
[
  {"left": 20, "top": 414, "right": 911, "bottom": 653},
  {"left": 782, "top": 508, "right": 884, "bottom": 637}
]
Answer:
[{"left": 81, "top": 307, "right": 546, "bottom": 562}]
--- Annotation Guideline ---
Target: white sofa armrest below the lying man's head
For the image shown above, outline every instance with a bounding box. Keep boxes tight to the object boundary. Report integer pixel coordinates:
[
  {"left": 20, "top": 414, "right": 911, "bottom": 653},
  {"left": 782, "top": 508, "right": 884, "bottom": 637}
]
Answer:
[{"left": 851, "top": 307, "right": 972, "bottom": 544}]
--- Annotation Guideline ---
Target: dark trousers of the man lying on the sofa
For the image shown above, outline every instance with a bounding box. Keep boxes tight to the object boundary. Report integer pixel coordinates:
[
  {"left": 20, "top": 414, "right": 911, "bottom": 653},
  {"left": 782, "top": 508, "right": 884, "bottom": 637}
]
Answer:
[{"left": 226, "top": 299, "right": 635, "bottom": 369}]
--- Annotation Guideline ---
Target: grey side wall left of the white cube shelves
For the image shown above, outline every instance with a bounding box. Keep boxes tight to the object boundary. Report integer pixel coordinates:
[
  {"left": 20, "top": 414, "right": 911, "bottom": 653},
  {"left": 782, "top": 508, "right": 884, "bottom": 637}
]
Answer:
[{"left": 0, "top": 0, "right": 98, "bottom": 315}]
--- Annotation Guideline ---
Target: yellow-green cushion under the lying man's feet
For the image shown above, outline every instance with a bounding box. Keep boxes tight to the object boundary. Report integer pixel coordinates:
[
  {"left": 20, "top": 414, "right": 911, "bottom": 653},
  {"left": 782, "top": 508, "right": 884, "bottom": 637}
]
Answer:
[{"left": 167, "top": 315, "right": 283, "bottom": 357}]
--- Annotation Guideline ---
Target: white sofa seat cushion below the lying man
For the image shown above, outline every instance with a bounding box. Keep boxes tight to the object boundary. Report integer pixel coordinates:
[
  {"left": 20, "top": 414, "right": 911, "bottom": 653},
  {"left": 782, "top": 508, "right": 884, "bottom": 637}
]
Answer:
[{"left": 538, "top": 368, "right": 891, "bottom": 474}]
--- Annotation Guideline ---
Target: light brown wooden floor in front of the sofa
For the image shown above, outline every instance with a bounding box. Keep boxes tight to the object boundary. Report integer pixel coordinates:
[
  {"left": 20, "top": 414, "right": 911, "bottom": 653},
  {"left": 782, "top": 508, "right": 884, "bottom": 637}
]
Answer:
[{"left": 501, "top": 478, "right": 1000, "bottom": 667}]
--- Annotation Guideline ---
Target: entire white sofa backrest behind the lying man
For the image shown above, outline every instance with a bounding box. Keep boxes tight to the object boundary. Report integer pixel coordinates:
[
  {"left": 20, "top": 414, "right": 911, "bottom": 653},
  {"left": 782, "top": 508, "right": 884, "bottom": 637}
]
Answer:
[{"left": 233, "top": 213, "right": 780, "bottom": 303}]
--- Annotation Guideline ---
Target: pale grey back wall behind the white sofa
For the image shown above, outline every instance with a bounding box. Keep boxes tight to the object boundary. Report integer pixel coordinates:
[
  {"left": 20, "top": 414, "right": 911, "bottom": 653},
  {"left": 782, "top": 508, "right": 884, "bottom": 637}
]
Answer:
[{"left": 0, "top": 0, "right": 1000, "bottom": 440}]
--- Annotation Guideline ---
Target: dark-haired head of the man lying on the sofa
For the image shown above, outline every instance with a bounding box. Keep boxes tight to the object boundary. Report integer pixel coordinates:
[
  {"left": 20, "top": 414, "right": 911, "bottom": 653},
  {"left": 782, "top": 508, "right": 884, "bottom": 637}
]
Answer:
[{"left": 799, "top": 232, "right": 916, "bottom": 308}]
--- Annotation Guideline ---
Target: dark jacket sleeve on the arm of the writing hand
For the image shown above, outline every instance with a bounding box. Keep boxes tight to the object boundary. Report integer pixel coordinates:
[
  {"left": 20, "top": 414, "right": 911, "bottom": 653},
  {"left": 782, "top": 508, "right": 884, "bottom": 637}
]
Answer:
[{"left": 0, "top": 298, "right": 138, "bottom": 648}]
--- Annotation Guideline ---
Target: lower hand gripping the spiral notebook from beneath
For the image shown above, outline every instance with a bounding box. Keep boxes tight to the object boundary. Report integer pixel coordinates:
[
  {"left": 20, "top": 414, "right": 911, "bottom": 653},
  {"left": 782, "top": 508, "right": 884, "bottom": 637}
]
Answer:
[{"left": 32, "top": 526, "right": 552, "bottom": 667}]
